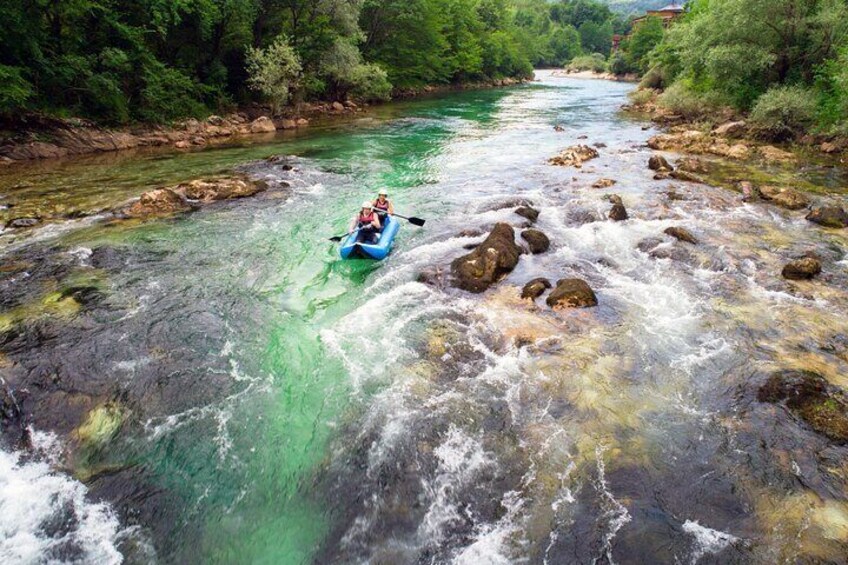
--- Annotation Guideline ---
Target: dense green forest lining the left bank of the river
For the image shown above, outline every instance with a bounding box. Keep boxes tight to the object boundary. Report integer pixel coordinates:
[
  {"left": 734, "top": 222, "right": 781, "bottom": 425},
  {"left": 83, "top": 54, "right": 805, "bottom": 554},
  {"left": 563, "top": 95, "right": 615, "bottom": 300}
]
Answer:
[{"left": 0, "top": 0, "right": 627, "bottom": 124}]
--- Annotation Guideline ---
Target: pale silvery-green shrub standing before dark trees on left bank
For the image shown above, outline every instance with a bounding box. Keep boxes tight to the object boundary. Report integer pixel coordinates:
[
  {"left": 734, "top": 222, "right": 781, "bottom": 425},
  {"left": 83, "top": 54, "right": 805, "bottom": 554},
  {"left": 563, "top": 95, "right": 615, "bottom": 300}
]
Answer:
[{"left": 247, "top": 35, "right": 301, "bottom": 113}]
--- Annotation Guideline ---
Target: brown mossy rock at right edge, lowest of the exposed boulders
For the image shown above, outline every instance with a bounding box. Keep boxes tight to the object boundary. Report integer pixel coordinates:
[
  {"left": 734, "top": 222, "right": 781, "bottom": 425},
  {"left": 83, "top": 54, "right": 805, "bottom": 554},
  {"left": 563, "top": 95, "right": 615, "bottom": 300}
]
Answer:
[{"left": 757, "top": 371, "right": 848, "bottom": 444}]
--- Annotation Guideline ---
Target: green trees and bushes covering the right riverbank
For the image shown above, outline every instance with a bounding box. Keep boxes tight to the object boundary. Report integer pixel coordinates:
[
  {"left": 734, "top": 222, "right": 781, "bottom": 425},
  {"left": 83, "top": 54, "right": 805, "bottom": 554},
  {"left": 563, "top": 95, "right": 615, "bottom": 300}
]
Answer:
[{"left": 629, "top": 0, "right": 848, "bottom": 141}]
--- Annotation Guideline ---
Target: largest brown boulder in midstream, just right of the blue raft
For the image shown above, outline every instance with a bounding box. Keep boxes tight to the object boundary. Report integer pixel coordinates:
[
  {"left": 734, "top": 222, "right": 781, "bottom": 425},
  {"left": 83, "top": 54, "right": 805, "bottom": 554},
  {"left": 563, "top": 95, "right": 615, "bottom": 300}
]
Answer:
[{"left": 451, "top": 223, "right": 521, "bottom": 293}]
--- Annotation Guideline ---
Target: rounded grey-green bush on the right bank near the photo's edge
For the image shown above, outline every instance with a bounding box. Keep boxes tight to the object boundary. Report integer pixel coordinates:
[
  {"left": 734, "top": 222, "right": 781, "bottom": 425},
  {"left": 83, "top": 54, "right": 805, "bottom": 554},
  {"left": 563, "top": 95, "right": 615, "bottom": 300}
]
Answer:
[{"left": 751, "top": 86, "right": 817, "bottom": 141}]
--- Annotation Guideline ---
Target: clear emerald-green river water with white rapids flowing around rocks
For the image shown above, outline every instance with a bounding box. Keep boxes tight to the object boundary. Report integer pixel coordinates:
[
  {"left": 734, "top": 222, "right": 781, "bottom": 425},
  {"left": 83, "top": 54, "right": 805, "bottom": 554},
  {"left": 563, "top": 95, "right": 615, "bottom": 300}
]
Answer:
[{"left": 0, "top": 73, "right": 848, "bottom": 564}]
